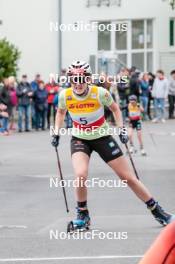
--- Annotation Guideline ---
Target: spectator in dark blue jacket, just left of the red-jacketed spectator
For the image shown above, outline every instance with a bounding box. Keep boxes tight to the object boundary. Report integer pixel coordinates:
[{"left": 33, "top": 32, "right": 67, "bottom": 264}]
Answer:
[{"left": 33, "top": 81, "right": 48, "bottom": 130}]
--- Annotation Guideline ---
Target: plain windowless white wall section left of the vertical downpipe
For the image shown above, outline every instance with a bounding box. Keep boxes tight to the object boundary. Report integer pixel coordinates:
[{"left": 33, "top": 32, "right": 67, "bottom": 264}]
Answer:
[{"left": 0, "top": 0, "right": 58, "bottom": 80}]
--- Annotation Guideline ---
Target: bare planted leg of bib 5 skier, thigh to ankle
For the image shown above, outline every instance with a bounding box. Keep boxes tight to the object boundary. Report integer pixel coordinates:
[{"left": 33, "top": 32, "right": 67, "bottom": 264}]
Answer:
[{"left": 72, "top": 151, "right": 89, "bottom": 202}]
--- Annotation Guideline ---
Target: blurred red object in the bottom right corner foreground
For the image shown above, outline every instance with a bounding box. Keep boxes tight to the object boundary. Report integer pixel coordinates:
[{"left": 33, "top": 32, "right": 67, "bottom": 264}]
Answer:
[{"left": 139, "top": 221, "right": 175, "bottom": 264}]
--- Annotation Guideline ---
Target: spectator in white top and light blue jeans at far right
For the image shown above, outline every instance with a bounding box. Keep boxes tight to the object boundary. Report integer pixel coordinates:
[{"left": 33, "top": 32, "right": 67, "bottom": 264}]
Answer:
[{"left": 152, "top": 70, "right": 168, "bottom": 123}]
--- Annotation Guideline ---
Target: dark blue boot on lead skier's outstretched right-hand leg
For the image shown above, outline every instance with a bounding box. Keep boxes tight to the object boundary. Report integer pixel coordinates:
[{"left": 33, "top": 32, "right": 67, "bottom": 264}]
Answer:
[{"left": 148, "top": 202, "right": 175, "bottom": 226}]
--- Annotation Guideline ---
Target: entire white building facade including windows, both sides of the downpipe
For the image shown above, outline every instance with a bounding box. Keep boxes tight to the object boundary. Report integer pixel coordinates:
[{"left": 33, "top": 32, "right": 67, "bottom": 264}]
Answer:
[{"left": 0, "top": 0, "right": 175, "bottom": 79}]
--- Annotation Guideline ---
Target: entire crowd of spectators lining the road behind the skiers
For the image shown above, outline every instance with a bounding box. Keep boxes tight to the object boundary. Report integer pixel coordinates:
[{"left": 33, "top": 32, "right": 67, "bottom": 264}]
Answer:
[{"left": 0, "top": 67, "right": 175, "bottom": 135}]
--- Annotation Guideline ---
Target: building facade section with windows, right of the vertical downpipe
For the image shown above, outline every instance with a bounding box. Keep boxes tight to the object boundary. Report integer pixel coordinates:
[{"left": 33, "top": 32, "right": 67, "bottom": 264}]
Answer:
[{"left": 63, "top": 0, "right": 175, "bottom": 74}]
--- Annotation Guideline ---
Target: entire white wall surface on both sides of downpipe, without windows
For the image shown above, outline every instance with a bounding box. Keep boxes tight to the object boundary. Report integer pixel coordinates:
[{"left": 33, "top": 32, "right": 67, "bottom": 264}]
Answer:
[{"left": 0, "top": 0, "right": 175, "bottom": 80}]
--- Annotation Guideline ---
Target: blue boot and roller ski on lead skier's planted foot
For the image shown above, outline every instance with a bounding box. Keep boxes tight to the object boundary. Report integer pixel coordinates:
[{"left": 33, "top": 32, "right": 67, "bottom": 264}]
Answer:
[{"left": 67, "top": 208, "right": 90, "bottom": 233}]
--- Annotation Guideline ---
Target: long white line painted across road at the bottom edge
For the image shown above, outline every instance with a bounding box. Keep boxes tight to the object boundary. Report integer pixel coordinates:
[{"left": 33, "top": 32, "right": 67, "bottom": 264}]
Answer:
[{"left": 0, "top": 255, "right": 143, "bottom": 262}]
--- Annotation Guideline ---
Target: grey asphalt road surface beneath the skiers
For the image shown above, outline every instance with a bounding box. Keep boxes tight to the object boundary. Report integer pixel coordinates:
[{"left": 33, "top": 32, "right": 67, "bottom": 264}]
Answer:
[{"left": 0, "top": 121, "right": 175, "bottom": 264}]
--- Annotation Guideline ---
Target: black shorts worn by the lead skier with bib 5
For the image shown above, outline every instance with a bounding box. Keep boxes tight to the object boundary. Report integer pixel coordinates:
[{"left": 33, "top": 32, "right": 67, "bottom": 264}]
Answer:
[{"left": 71, "top": 136, "right": 123, "bottom": 162}]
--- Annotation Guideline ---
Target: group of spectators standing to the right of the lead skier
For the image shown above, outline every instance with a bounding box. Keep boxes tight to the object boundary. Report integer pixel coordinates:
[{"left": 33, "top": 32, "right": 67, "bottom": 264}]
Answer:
[{"left": 96, "top": 67, "right": 175, "bottom": 123}]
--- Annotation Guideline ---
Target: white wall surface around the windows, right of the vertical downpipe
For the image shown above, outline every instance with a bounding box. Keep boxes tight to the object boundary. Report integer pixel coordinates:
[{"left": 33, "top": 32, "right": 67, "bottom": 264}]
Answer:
[{"left": 63, "top": 0, "right": 175, "bottom": 70}]
